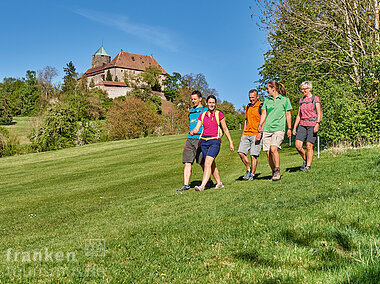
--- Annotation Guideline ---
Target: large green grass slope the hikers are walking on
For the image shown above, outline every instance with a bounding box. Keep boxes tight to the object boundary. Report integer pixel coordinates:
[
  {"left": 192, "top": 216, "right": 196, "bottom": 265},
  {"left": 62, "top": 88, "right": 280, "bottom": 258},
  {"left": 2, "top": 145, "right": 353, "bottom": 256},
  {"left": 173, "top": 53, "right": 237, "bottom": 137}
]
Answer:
[{"left": 0, "top": 132, "right": 380, "bottom": 283}]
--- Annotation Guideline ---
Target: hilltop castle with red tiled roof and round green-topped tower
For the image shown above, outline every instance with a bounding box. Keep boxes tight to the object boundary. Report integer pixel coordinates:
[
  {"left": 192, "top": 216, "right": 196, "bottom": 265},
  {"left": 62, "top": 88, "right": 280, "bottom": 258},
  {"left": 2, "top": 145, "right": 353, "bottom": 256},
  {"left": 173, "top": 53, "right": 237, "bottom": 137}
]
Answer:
[{"left": 83, "top": 46, "right": 166, "bottom": 98}]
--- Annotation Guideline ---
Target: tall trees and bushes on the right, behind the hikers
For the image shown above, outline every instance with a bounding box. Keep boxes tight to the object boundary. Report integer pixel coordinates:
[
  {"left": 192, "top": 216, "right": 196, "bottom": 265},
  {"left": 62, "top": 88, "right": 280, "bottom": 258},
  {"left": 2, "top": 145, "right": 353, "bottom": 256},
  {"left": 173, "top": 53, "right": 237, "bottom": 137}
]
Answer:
[{"left": 251, "top": 0, "right": 380, "bottom": 145}]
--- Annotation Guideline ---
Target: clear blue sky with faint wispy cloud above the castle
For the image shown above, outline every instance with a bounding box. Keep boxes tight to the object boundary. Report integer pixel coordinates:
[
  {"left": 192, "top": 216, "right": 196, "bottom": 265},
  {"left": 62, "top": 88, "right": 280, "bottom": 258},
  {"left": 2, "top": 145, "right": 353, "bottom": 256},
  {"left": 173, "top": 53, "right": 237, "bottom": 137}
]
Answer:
[{"left": 0, "top": 0, "right": 267, "bottom": 108}]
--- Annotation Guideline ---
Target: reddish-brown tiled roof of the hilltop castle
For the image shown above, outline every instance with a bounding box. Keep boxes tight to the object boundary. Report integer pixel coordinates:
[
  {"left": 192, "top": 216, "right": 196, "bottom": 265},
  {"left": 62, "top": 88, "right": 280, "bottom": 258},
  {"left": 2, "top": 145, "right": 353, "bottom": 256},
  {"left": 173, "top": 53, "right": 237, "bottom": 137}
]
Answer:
[{"left": 85, "top": 51, "right": 166, "bottom": 75}]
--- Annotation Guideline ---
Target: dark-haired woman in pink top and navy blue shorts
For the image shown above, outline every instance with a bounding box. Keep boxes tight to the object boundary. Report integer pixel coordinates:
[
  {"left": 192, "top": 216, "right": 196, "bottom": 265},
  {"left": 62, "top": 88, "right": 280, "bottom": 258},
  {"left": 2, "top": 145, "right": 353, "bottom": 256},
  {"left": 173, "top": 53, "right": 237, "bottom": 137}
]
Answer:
[{"left": 190, "top": 95, "right": 234, "bottom": 191}]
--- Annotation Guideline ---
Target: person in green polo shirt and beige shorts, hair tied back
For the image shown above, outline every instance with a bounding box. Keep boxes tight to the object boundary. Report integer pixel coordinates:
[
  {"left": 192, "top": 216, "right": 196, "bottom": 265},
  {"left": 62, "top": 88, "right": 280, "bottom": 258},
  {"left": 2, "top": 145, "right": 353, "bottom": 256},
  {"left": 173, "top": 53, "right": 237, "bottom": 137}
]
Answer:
[{"left": 258, "top": 81, "right": 292, "bottom": 181}]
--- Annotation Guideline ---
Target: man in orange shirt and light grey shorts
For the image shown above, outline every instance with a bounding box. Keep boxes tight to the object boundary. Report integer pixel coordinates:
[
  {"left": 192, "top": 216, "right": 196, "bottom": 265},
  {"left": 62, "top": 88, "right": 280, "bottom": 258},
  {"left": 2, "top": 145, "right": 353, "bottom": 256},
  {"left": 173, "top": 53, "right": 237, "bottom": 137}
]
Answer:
[{"left": 238, "top": 89, "right": 262, "bottom": 180}]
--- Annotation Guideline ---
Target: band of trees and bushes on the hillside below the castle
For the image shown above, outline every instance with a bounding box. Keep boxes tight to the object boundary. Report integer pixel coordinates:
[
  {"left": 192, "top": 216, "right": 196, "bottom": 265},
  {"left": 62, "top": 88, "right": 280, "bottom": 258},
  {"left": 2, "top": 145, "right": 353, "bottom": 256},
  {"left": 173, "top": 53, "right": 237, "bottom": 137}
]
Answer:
[{"left": 0, "top": 62, "right": 244, "bottom": 156}]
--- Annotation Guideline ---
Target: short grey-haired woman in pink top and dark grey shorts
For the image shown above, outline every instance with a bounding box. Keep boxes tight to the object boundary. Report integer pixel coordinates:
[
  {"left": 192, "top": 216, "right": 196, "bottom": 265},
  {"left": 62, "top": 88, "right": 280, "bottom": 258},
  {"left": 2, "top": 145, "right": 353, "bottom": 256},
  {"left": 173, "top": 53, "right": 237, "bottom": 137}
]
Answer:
[{"left": 293, "top": 81, "right": 322, "bottom": 171}]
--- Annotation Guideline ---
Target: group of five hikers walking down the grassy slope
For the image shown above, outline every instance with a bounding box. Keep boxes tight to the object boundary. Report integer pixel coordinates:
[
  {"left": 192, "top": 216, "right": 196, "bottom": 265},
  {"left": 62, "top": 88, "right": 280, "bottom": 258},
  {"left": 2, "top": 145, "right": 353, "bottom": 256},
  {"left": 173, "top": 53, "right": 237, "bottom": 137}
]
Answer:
[{"left": 178, "top": 81, "right": 322, "bottom": 191}]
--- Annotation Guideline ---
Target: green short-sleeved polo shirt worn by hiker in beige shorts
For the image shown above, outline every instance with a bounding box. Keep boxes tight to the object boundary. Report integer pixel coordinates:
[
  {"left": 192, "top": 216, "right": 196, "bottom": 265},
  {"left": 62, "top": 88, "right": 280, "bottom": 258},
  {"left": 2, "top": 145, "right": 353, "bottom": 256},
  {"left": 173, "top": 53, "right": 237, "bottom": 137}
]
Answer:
[{"left": 263, "top": 95, "right": 292, "bottom": 132}]
